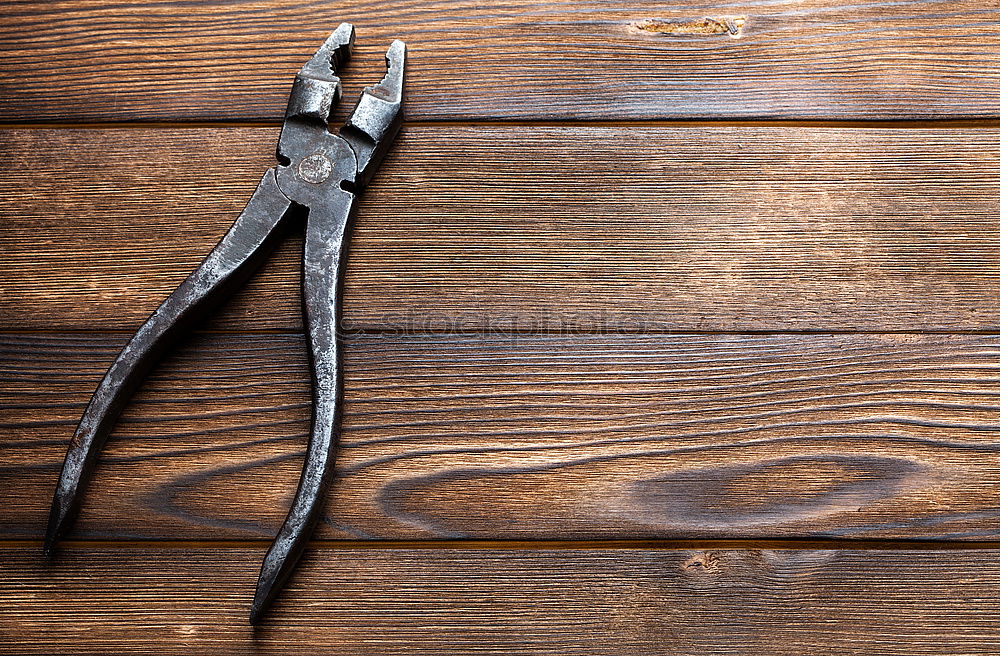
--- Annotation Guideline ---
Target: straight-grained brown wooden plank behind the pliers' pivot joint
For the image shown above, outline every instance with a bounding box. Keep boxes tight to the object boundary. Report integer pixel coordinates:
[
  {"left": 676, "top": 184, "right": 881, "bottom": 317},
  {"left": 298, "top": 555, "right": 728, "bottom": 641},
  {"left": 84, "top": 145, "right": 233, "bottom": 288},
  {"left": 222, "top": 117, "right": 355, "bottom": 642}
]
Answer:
[{"left": 0, "top": 126, "right": 1000, "bottom": 332}]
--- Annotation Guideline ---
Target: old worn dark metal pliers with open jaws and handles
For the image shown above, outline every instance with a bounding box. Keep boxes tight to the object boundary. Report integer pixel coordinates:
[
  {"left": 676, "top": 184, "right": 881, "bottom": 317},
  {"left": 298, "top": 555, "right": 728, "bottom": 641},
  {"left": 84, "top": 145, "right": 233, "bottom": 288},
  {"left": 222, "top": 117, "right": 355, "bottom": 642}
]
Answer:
[{"left": 45, "top": 23, "right": 406, "bottom": 624}]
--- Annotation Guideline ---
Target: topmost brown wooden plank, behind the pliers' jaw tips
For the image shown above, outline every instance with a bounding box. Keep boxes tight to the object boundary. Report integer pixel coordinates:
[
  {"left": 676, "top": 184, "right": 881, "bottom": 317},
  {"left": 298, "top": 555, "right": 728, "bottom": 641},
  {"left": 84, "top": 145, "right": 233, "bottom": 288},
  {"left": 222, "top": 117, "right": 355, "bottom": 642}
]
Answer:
[{"left": 0, "top": 0, "right": 1000, "bottom": 121}]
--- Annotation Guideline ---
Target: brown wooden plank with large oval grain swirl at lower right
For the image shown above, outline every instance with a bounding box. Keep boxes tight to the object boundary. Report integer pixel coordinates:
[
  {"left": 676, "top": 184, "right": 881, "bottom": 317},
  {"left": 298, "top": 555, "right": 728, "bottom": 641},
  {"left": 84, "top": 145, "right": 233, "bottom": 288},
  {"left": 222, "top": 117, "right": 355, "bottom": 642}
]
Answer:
[{"left": 0, "top": 335, "right": 1000, "bottom": 540}]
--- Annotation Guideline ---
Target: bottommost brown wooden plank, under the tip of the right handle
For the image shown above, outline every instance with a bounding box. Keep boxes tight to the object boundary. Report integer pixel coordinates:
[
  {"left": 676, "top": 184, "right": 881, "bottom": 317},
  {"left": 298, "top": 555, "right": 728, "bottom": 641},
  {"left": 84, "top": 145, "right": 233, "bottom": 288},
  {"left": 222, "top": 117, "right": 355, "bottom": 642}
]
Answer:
[{"left": 0, "top": 548, "right": 1000, "bottom": 656}]
